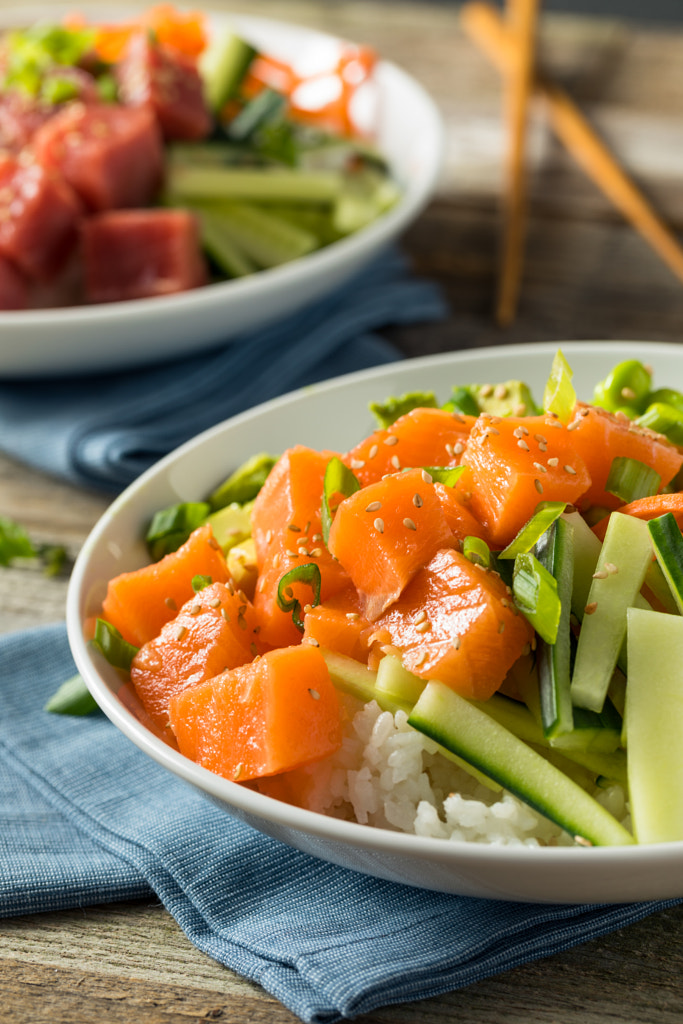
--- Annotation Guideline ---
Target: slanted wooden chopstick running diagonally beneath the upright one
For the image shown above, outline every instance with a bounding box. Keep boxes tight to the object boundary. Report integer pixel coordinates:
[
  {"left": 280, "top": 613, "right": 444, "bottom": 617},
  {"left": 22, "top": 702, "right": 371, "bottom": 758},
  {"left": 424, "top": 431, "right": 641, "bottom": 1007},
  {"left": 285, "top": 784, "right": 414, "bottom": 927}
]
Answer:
[{"left": 461, "top": 0, "right": 683, "bottom": 292}]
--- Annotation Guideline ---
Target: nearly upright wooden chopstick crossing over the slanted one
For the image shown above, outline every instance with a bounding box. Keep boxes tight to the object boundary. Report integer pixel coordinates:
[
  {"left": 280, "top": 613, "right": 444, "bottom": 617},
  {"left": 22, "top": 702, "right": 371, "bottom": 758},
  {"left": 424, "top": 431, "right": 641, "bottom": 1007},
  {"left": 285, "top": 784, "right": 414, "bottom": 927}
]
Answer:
[{"left": 496, "top": 0, "right": 541, "bottom": 327}]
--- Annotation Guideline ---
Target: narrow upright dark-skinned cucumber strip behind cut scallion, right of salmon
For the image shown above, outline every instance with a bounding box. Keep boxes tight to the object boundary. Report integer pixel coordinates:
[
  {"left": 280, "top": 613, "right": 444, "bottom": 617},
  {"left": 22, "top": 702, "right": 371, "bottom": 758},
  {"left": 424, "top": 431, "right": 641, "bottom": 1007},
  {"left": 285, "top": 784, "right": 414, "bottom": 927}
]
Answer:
[{"left": 536, "top": 519, "right": 573, "bottom": 739}]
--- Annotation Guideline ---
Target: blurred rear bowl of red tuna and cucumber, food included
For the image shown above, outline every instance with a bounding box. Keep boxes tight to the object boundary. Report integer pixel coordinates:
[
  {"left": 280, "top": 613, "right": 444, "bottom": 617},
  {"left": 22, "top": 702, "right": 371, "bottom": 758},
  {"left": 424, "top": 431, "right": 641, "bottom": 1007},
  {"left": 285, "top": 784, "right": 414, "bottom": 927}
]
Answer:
[{"left": 0, "top": 4, "right": 441, "bottom": 375}]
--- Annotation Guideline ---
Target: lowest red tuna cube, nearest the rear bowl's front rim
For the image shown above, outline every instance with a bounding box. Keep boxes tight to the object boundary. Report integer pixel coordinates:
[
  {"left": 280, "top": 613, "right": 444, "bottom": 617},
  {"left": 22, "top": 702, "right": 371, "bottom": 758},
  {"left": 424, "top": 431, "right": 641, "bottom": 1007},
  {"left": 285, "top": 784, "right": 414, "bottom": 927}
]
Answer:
[{"left": 83, "top": 210, "right": 206, "bottom": 302}]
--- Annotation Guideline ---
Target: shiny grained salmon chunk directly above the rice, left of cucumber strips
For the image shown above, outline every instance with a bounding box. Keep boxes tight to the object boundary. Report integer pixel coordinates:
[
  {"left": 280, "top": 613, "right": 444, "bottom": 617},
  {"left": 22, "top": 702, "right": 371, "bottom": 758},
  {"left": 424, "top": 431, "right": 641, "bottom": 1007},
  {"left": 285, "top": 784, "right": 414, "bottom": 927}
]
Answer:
[{"left": 375, "top": 549, "right": 533, "bottom": 700}]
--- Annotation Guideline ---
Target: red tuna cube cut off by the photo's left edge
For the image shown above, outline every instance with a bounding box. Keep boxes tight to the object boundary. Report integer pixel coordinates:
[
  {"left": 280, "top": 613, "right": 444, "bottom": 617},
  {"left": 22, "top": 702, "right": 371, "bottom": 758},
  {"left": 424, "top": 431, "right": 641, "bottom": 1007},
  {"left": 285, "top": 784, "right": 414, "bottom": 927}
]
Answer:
[{"left": 0, "top": 158, "right": 82, "bottom": 281}]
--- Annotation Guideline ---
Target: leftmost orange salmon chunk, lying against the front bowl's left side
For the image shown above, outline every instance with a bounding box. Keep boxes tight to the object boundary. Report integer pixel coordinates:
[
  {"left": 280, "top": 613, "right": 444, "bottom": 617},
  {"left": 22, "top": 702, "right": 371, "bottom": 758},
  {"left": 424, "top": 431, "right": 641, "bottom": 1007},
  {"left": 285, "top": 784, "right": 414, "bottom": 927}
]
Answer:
[{"left": 102, "top": 524, "right": 230, "bottom": 647}]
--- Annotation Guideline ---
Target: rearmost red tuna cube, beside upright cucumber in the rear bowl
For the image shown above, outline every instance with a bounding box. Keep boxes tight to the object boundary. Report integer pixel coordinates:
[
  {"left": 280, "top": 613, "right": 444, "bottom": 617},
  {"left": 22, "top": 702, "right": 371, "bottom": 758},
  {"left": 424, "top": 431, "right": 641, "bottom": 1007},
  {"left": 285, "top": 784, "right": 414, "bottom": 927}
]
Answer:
[{"left": 117, "top": 33, "right": 211, "bottom": 140}]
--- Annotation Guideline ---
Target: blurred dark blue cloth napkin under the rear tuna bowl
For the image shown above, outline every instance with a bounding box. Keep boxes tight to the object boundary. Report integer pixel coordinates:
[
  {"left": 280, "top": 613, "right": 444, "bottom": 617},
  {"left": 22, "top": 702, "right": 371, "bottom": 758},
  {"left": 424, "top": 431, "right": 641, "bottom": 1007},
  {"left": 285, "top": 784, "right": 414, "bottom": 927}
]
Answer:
[{"left": 0, "top": 249, "right": 446, "bottom": 492}]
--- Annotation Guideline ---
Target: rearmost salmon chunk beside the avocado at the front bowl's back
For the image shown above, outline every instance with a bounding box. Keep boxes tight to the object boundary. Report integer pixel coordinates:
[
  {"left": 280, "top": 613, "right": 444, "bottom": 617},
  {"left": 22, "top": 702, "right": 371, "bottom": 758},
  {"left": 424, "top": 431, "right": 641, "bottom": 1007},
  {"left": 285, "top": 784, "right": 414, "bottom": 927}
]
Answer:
[{"left": 343, "top": 409, "right": 475, "bottom": 487}]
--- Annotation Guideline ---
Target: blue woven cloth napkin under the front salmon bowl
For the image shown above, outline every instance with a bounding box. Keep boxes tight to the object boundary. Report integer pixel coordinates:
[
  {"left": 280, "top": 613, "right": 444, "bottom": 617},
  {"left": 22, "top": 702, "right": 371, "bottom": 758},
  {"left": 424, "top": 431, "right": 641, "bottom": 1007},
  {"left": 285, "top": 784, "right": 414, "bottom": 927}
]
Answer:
[{"left": 0, "top": 625, "right": 677, "bottom": 1024}]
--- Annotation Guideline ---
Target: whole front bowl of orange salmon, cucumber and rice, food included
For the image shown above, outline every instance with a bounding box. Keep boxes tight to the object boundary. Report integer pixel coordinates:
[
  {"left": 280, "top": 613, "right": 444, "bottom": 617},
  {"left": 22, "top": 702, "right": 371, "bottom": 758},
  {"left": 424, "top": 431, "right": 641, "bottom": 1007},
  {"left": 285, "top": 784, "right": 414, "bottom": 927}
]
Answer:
[{"left": 68, "top": 342, "right": 683, "bottom": 902}]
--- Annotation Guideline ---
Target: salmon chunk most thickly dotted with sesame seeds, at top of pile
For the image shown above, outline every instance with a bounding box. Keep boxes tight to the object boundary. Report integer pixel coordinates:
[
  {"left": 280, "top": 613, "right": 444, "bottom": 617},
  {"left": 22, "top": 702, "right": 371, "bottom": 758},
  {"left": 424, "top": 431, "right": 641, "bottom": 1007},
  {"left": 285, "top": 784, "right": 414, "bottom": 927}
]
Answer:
[{"left": 462, "top": 414, "right": 591, "bottom": 548}]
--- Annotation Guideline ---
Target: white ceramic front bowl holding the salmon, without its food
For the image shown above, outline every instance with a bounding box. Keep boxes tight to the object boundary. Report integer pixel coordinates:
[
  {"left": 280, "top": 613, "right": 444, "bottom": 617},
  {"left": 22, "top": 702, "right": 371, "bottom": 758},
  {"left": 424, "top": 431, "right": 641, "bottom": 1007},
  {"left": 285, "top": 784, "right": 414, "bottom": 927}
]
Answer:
[{"left": 67, "top": 342, "right": 683, "bottom": 902}]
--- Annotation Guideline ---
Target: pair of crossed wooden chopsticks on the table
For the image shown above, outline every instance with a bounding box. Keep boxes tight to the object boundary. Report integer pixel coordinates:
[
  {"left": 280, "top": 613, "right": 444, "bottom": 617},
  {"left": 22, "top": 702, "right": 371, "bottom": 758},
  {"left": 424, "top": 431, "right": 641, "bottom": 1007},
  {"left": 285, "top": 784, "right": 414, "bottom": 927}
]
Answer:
[{"left": 461, "top": 0, "right": 683, "bottom": 326}]
